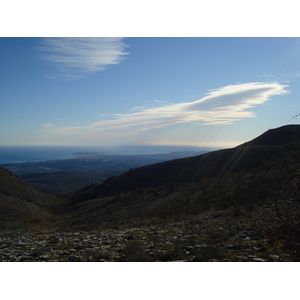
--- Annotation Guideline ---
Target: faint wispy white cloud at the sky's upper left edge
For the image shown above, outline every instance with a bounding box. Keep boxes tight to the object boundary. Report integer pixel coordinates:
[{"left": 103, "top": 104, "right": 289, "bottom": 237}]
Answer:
[{"left": 36, "top": 37, "right": 128, "bottom": 79}]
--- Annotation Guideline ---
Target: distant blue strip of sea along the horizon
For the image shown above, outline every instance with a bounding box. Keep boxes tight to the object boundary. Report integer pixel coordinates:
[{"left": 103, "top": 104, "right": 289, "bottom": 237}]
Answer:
[{"left": 0, "top": 146, "right": 213, "bottom": 165}]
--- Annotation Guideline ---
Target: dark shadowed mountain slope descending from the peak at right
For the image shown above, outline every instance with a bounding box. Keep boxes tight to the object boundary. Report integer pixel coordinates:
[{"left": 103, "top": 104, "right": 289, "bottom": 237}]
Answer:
[{"left": 72, "top": 125, "right": 300, "bottom": 203}]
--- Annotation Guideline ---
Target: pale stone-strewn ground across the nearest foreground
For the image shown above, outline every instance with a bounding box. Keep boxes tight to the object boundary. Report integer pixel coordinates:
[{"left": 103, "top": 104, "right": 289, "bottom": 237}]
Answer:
[{"left": 0, "top": 212, "right": 283, "bottom": 262}]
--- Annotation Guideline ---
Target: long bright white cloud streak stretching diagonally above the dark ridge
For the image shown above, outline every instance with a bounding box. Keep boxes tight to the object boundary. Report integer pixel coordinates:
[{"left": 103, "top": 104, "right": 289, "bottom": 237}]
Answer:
[{"left": 39, "top": 82, "right": 289, "bottom": 142}]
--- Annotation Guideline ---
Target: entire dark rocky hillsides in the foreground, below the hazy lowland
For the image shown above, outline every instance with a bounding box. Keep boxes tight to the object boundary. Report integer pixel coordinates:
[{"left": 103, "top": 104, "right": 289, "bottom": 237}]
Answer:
[{"left": 0, "top": 125, "right": 300, "bottom": 262}]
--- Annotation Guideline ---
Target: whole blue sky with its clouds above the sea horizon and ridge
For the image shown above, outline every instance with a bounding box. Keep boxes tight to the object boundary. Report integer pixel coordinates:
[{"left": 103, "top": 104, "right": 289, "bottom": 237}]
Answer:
[{"left": 0, "top": 37, "right": 300, "bottom": 148}]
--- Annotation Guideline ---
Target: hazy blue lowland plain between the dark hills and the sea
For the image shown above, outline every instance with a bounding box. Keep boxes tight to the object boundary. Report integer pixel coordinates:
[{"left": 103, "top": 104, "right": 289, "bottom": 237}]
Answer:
[{"left": 0, "top": 149, "right": 208, "bottom": 194}]
